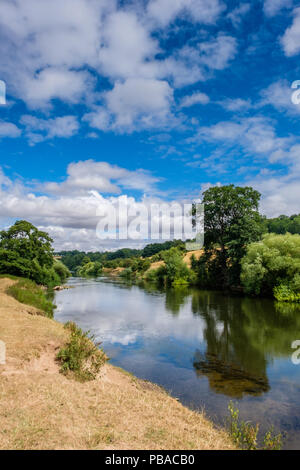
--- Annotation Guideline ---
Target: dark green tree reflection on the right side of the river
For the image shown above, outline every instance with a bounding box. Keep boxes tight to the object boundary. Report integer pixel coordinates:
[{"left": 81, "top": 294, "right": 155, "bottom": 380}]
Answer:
[{"left": 192, "top": 290, "right": 300, "bottom": 398}]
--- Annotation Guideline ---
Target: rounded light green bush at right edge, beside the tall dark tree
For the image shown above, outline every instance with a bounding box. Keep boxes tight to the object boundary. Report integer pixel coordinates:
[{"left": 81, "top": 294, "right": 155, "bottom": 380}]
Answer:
[{"left": 241, "top": 234, "right": 300, "bottom": 295}]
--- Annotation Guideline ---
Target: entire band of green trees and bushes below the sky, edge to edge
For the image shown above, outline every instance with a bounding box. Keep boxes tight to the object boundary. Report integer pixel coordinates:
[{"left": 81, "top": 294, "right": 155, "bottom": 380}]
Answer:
[{"left": 0, "top": 185, "right": 300, "bottom": 301}]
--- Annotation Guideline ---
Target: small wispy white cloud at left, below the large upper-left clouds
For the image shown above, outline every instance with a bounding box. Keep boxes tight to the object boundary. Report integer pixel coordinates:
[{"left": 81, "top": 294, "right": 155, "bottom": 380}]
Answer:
[{"left": 20, "top": 115, "right": 79, "bottom": 144}]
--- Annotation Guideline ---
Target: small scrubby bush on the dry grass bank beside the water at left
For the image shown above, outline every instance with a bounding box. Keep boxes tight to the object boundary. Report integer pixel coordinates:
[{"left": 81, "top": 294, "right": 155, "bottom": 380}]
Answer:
[{"left": 57, "top": 322, "right": 107, "bottom": 382}]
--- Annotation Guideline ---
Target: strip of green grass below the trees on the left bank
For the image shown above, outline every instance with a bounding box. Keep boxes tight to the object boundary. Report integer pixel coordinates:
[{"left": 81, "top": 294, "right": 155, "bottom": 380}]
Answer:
[{"left": 2, "top": 275, "right": 55, "bottom": 318}]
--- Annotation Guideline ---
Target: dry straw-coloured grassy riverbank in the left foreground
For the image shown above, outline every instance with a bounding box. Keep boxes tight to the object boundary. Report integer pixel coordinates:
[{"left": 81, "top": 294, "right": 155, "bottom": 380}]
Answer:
[{"left": 0, "top": 279, "right": 234, "bottom": 450}]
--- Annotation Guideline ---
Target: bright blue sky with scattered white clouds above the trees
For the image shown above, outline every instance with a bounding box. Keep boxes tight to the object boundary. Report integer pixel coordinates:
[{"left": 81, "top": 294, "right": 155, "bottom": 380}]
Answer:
[{"left": 0, "top": 0, "right": 300, "bottom": 250}]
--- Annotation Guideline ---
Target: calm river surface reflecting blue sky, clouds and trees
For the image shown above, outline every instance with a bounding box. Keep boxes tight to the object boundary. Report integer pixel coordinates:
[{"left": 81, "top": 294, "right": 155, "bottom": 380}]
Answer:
[{"left": 55, "top": 278, "right": 300, "bottom": 449}]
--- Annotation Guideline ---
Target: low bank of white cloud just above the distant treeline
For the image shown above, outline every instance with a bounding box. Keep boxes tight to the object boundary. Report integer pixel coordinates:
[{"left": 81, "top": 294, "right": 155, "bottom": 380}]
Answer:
[{"left": 0, "top": 164, "right": 192, "bottom": 250}]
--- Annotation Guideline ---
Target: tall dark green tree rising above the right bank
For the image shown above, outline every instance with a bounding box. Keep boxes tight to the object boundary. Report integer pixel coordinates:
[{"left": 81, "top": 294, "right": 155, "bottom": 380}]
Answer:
[{"left": 203, "top": 185, "right": 263, "bottom": 288}]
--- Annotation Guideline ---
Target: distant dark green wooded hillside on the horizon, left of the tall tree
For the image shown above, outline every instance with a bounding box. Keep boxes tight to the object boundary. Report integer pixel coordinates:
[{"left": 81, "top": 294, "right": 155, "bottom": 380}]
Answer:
[{"left": 56, "top": 240, "right": 184, "bottom": 271}]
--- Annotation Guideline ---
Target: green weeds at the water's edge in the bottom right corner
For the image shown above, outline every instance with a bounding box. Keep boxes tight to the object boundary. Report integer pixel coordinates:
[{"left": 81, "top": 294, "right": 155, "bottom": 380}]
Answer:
[{"left": 228, "top": 402, "right": 283, "bottom": 450}]
